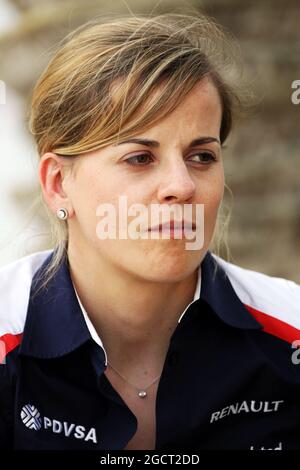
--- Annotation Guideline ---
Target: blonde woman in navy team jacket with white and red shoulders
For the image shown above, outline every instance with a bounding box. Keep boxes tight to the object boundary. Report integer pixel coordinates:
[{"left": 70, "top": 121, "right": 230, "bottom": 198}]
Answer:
[{"left": 0, "top": 14, "right": 300, "bottom": 450}]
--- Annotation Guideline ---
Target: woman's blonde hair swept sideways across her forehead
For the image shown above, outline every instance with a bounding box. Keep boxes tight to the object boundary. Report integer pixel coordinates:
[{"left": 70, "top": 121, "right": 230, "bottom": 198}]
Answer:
[{"left": 29, "top": 13, "right": 247, "bottom": 284}]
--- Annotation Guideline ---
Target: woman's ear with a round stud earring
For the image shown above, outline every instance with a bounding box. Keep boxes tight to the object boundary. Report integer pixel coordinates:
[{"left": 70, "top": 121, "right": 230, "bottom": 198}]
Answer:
[{"left": 38, "top": 152, "right": 74, "bottom": 217}]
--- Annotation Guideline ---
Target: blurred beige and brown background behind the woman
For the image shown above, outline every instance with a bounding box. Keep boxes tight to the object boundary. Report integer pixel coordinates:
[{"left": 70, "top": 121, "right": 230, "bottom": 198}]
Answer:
[{"left": 0, "top": 0, "right": 300, "bottom": 283}]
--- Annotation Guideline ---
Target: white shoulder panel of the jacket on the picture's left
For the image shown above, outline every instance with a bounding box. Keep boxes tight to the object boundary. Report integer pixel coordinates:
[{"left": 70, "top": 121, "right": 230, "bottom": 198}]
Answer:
[{"left": 0, "top": 250, "right": 52, "bottom": 340}]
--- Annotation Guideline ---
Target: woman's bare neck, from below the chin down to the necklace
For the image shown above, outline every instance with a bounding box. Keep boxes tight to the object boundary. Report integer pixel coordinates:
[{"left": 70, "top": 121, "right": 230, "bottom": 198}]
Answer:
[{"left": 68, "top": 244, "right": 198, "bottom": 368}]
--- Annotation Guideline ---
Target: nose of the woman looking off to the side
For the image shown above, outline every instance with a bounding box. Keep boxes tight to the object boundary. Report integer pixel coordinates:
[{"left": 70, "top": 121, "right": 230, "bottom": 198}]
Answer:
[{"left": 157, "top": 156, "right": 196, "bottom": 203}]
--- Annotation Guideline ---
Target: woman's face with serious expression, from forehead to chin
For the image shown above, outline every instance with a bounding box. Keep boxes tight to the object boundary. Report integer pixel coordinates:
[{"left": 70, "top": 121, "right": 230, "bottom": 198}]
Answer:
[{"left": 63, "top": 80, "right": 224, "bottom": 282}]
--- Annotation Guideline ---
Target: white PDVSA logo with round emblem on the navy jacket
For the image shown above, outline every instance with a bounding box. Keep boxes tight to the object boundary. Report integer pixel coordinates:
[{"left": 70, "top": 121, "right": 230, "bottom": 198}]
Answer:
[{"left": 21, "top": 405, "right": 97, "bottom": 444}]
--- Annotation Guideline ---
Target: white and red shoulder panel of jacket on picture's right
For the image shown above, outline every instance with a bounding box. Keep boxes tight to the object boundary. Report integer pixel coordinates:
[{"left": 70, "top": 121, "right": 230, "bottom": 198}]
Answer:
[{"left": 213, "top": 254, "right": 300, "bottom": 340}]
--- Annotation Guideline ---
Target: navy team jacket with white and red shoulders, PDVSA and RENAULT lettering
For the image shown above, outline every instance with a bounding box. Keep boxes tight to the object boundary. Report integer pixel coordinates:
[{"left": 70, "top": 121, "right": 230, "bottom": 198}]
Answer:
[{"left": 0, "top": 250, "right": 300, "bottom": 451}]
